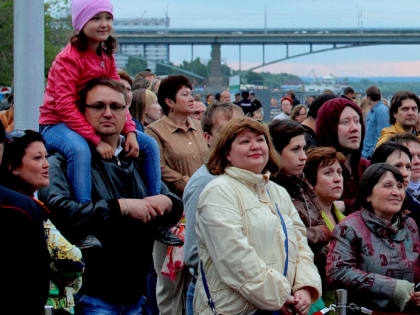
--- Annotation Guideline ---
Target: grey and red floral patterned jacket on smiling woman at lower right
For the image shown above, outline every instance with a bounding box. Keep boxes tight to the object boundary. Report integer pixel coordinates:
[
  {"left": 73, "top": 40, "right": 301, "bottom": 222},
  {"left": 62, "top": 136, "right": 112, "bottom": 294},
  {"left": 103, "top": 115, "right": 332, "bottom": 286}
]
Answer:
[{"left": 326, "top": 209, "right": 420, "bottom": 311}]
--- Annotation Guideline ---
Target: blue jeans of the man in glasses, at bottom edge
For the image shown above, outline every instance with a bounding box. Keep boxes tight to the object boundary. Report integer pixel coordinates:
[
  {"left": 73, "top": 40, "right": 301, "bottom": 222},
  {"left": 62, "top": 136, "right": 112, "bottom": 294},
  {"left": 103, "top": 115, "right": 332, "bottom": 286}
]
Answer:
[{"left": 75, "top": 294, "right": 146, "bottom": 315}]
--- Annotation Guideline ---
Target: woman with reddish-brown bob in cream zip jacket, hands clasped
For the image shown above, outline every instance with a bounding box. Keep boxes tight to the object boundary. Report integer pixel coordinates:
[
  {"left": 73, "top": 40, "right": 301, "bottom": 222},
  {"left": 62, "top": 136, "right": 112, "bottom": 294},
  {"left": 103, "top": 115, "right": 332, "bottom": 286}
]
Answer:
[{"left": 194, "top": 118, "right": 321, "bottom": 315}]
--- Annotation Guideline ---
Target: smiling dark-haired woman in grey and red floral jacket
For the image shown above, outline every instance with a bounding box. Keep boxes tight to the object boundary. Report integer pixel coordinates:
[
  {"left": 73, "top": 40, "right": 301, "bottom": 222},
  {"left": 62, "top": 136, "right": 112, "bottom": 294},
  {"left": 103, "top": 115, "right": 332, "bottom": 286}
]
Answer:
[{"left": 326, "top": 163, "right": 420, "bottom": 312}]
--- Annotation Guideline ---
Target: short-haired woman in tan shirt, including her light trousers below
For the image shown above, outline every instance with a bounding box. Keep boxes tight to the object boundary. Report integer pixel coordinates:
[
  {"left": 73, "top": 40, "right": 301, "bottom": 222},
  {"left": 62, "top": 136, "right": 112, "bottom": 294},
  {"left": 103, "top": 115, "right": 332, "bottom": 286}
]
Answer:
[{"left": 146, "top": 76, "right": 208, "bottom": 314}]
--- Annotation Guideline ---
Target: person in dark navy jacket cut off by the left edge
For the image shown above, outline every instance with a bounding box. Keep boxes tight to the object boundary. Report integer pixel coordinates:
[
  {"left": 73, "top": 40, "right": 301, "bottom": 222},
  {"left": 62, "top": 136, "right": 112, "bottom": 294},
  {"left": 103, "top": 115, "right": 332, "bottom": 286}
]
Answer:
[{"left": 0, "top": 122, "right": 50, "bottom": 314}]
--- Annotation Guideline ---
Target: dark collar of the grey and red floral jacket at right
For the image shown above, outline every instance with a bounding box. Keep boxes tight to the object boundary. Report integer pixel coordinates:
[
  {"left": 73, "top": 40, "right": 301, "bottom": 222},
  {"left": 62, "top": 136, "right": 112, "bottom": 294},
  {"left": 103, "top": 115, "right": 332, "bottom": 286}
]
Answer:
[{"left": 360, "top": 209, "right": 406, "bottom": 242}]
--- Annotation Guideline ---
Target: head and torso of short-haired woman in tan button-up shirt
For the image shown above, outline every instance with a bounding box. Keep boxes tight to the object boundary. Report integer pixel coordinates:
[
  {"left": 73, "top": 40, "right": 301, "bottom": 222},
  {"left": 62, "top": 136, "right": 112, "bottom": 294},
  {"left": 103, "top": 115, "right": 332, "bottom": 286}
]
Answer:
[{"left": 146, "top": 75, "right": 208, "bottom": 196}]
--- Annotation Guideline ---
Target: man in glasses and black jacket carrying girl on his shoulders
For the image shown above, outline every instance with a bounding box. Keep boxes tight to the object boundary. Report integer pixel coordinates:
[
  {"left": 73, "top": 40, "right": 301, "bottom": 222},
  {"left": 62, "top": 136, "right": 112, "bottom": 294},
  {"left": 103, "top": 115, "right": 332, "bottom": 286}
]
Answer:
[{"left": 39, "top": 78, "right": 182, "bottom": 314}]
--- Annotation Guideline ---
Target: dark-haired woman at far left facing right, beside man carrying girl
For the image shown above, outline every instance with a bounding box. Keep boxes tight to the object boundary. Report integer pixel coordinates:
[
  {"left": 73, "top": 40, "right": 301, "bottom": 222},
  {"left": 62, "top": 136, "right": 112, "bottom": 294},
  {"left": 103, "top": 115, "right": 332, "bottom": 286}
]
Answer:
[{"left": 0, "top": 130, "right": 84, "bottom": 314}]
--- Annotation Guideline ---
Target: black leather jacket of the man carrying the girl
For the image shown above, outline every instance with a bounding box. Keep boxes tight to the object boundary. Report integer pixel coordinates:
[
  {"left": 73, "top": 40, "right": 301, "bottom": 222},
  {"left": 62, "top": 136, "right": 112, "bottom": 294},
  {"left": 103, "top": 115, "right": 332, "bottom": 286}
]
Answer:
[{"left": 39, "top": 148, "right": 182, "bottom": 304}]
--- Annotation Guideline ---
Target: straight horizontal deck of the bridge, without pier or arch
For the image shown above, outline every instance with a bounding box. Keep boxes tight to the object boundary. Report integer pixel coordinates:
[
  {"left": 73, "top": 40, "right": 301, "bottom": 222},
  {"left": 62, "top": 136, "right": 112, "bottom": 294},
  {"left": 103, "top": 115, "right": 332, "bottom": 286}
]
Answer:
[{"left": 116, "top": 28, "right": 420, "bottom": 45}]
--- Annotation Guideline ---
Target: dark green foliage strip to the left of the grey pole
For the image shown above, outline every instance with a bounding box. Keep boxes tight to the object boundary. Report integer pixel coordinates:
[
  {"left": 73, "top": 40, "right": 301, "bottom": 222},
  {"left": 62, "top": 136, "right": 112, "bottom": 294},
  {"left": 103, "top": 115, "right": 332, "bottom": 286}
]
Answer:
[{"left": 0, "top": 0, "right": 13, "bottom": 85}]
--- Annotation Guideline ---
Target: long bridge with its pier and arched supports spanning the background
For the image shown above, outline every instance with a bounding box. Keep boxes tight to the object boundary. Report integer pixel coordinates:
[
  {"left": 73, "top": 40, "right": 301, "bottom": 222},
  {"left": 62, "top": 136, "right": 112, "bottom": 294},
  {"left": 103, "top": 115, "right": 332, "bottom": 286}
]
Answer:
[{"left": 115, "top": 26, "right": 420, "bottom": 90}]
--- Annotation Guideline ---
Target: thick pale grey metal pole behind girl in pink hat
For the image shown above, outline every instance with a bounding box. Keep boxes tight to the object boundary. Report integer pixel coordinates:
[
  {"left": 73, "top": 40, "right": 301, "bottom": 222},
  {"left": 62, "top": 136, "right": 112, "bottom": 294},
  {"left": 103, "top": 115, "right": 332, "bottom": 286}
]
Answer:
[{"left": 13, "top": 0, "right": 45, "bottom": 130}]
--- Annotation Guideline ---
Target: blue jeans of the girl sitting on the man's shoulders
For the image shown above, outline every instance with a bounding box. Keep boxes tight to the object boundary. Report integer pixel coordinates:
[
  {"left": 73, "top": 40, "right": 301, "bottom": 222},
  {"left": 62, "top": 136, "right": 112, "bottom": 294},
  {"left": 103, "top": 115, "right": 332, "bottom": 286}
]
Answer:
[{"left": 40, "top": 123, "right": 161, "bottom": 203}]
